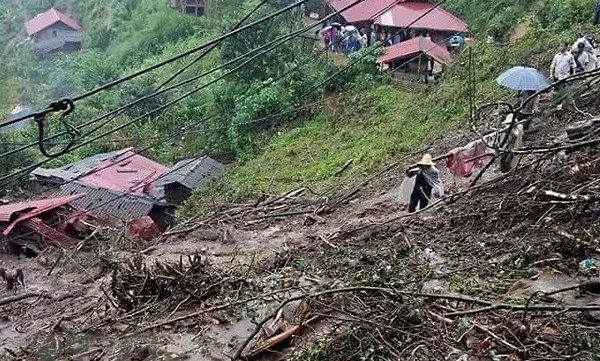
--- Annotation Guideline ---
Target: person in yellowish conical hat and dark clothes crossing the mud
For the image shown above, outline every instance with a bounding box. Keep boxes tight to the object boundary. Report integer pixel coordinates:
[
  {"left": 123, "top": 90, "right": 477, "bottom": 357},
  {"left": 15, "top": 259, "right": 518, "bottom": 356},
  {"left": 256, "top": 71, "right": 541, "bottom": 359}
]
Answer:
[{"left": 406, "top": 154, "right": 444, "bottom": 213}]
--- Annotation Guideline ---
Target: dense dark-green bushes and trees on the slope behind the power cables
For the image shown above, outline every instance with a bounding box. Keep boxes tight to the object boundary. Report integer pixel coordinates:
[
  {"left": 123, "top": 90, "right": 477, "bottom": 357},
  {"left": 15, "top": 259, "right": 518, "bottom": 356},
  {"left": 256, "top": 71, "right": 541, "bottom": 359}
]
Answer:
[{"left": 0, "top": 0, "right": 333, "bottom": 175}]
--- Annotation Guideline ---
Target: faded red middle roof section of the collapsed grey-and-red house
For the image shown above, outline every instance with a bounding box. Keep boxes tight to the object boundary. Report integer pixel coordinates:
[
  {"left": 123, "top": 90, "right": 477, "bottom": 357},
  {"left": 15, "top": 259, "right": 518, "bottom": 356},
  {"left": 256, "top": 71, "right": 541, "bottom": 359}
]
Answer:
[{"left": 79, "top": 151, "right": 169, "bottom": 194}]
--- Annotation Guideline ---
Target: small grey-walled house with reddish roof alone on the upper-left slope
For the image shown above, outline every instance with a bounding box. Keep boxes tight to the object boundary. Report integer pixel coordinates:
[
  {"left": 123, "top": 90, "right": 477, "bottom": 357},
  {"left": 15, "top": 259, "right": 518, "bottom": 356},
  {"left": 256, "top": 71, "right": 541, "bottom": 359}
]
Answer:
[{"left": 25, "top": 8, "right": 83, "bottom": 54}]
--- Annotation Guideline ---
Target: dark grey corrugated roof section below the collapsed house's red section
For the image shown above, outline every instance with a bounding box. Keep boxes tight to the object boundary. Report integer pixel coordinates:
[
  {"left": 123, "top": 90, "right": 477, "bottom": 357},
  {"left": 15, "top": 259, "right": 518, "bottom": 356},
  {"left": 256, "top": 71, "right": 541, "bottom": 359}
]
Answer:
[{"left": 56, "top": 182, "right": 157, "bottom": 220}]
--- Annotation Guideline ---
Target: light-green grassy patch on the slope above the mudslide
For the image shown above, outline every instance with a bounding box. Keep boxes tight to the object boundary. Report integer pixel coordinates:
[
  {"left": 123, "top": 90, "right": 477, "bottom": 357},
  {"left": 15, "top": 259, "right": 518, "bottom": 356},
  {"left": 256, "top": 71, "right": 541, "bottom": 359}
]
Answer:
[{"left": 182, "top": 85, "right": 460, "bottom": 217}]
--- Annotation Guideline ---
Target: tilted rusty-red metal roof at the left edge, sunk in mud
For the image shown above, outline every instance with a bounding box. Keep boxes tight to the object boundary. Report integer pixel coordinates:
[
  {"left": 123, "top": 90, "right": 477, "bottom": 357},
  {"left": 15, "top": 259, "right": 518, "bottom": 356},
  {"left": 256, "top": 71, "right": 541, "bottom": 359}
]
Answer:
[{"left": 0, "top": 193, "right": 85, "bottom": 235}]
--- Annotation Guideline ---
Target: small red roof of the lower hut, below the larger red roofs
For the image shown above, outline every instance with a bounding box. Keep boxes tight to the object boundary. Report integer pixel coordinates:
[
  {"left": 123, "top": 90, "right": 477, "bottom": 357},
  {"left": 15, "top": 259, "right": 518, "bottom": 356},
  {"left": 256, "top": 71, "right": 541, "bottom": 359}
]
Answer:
[{"left": 377, "top": 36, "right": 451, "bottom": 64}]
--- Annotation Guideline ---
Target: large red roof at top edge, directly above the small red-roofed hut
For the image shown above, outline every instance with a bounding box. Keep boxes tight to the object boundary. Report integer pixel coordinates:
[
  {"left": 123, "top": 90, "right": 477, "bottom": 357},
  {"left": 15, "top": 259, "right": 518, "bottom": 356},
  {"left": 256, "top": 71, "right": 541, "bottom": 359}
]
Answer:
[{"left": 374, "top": 1, "right": 469, "bottom": 33}]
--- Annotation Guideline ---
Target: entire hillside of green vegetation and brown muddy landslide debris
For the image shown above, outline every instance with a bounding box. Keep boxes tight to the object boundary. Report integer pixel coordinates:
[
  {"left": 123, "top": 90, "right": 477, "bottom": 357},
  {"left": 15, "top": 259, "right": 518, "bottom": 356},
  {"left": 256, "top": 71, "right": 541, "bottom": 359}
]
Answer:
[{"left": 0, "top": 0, "right": 600, "bottom": 361}]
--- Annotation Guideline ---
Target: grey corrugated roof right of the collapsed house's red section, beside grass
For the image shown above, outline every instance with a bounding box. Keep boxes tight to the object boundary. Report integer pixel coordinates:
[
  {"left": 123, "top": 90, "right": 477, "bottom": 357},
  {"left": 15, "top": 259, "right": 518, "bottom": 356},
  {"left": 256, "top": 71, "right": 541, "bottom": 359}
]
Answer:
[{"left": 154, "top": 157, "right": 225, "bottom": 189}]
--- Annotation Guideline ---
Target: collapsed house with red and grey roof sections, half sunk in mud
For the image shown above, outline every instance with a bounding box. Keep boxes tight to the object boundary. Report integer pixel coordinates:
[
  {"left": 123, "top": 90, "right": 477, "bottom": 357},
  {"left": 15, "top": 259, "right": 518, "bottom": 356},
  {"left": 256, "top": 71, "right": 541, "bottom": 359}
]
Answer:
[{"left": 30, "top": 148, "right": 224, "bottom": 231}]
